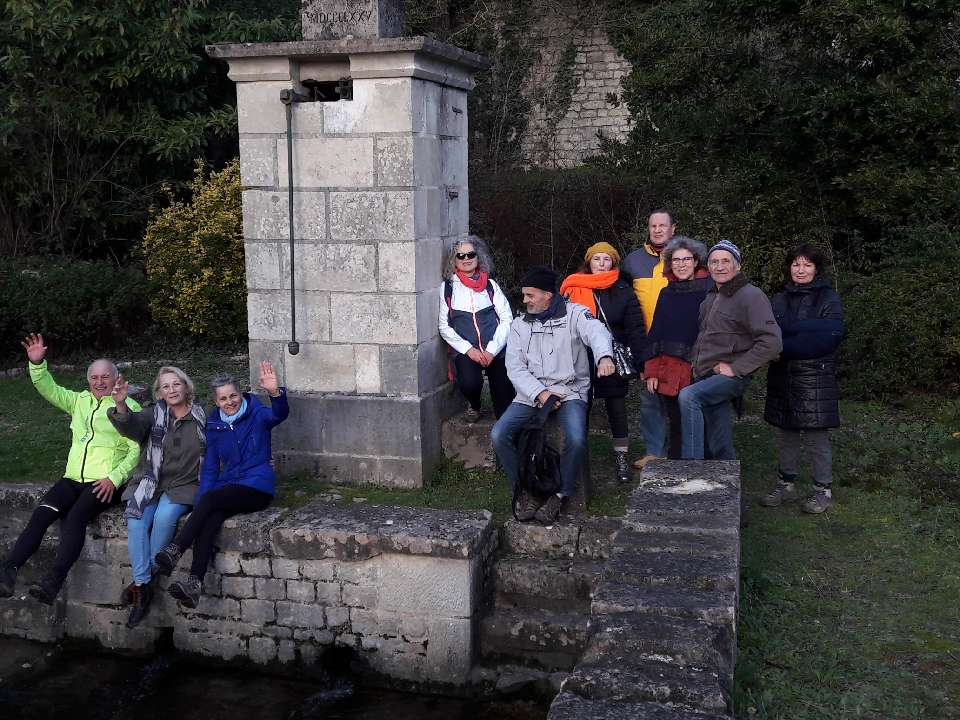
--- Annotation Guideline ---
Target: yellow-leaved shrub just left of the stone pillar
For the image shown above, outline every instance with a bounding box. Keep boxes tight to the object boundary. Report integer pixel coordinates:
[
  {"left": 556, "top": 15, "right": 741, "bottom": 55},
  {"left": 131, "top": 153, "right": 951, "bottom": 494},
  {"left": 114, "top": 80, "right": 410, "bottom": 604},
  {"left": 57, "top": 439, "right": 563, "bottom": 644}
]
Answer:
[{"left": 143, "top": 160, "right": 247, "bottom": 339}]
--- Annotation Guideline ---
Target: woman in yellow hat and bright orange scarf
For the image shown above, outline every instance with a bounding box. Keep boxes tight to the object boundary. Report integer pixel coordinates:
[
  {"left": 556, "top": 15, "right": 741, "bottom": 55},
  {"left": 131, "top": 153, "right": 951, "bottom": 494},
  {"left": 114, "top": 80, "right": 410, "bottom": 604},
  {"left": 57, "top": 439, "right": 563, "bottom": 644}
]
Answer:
[{"left": 560, "top": 242, "right": 644, "bottom": 482}]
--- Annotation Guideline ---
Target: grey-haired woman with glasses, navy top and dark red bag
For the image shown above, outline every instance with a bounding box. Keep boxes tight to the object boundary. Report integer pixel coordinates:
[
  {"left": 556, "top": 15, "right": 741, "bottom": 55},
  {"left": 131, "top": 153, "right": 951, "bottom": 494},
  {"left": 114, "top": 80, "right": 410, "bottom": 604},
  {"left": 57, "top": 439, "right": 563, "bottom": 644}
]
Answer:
[{"left": 642, "top": 235, "right": 713, "bottom": 459}]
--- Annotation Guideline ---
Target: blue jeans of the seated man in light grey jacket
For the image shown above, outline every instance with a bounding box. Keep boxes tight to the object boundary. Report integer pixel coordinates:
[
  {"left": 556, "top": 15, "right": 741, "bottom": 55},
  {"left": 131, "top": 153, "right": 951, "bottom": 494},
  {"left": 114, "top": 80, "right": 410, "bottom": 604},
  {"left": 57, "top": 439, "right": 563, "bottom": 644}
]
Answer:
[{"left": 490, "top": 400, "right": 587, "bottom": 497}]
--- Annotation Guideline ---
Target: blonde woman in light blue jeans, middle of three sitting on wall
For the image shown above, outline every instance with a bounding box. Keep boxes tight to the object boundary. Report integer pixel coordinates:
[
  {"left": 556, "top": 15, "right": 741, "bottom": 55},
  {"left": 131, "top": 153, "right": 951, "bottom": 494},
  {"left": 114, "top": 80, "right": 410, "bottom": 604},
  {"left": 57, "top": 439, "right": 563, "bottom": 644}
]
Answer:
[{"left": 107, "top": 366, "right": 207, "bottom": 627}]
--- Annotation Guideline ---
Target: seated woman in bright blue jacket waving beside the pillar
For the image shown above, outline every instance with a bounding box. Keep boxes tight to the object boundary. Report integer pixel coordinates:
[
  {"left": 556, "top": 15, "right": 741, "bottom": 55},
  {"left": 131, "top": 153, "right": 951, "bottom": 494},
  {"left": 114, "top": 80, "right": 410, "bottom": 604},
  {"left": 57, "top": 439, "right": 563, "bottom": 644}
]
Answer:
[{"left": 155, "top": 361, "right": 290, "bottom": 608}]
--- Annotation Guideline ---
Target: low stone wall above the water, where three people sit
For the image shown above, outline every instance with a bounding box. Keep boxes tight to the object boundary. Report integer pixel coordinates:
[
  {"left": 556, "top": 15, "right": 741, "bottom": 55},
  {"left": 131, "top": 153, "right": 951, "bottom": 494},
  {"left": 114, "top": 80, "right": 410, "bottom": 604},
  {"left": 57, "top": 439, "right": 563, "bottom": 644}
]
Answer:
[{"left": 0, "top": 485, "right": 496, "bottom": 686}]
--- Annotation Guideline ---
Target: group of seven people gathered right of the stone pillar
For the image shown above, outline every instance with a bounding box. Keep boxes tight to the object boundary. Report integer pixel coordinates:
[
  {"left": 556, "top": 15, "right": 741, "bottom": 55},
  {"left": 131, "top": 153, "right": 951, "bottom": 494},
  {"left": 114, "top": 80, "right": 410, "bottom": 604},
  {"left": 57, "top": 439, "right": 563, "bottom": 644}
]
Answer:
[{"left": 439, "top": 209, "right": 844, "bottom": 523}]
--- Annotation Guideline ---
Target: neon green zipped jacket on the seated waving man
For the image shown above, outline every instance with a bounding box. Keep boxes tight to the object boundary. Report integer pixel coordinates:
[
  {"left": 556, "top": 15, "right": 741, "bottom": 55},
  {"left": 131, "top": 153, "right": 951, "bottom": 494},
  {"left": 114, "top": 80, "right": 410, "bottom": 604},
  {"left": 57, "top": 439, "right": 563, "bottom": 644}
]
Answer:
[{"left": 28, "top": 360, "right": 140, "bottom": 487}]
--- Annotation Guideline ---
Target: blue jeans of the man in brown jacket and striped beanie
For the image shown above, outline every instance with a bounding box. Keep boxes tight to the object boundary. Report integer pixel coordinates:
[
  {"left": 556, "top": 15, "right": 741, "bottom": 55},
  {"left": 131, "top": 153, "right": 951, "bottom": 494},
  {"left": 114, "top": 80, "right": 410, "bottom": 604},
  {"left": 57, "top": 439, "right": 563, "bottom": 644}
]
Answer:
[{"left": 678, "top": 375, "right": 751, "bottom": 460}]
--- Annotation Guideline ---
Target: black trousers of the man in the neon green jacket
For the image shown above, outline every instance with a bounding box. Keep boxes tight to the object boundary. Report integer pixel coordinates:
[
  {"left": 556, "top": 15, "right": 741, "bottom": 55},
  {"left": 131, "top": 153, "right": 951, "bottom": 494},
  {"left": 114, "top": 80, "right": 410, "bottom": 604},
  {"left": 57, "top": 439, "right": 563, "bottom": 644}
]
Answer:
[{"left": 7, "top": 478, "right": 121, "bottom": 587}]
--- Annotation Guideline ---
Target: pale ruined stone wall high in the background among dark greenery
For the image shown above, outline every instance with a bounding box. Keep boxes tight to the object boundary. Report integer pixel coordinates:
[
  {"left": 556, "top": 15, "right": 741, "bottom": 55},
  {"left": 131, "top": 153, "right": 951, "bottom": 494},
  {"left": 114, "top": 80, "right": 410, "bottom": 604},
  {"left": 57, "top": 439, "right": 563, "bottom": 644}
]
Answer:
[{"left": 522, "top": 0, "right": 631, "bottom": 167}]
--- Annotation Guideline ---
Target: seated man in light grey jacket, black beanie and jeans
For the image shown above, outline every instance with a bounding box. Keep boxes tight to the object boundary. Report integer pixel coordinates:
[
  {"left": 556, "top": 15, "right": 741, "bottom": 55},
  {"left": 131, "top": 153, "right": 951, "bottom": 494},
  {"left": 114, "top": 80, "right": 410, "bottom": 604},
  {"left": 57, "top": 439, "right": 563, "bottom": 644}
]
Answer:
[{"left": 491, "top": 268, "right": 615, "bottom": 523}]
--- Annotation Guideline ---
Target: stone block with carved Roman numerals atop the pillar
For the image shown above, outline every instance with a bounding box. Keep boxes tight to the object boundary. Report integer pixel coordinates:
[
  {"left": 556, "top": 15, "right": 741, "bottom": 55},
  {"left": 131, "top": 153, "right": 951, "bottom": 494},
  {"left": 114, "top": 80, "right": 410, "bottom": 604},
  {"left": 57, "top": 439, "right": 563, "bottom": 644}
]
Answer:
[{"left": 301, "top": 0, "right": 403, "bottom": 40}]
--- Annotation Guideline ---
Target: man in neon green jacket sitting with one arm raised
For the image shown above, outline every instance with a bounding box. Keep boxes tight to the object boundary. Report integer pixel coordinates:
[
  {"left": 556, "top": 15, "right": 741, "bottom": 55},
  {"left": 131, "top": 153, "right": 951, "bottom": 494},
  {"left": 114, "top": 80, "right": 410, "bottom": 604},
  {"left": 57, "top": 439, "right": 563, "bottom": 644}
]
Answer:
[{"left": 0, "top": 334, "right": 140, "bottom": 605}]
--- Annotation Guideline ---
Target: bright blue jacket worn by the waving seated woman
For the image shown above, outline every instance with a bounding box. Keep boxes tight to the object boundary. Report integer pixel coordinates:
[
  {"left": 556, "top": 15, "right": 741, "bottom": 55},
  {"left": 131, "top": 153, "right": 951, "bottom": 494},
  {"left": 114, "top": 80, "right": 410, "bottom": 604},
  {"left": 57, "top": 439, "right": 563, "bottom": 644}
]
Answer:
[{"left": 196, "top": 388, "right": 290, "bottom": 502}]
